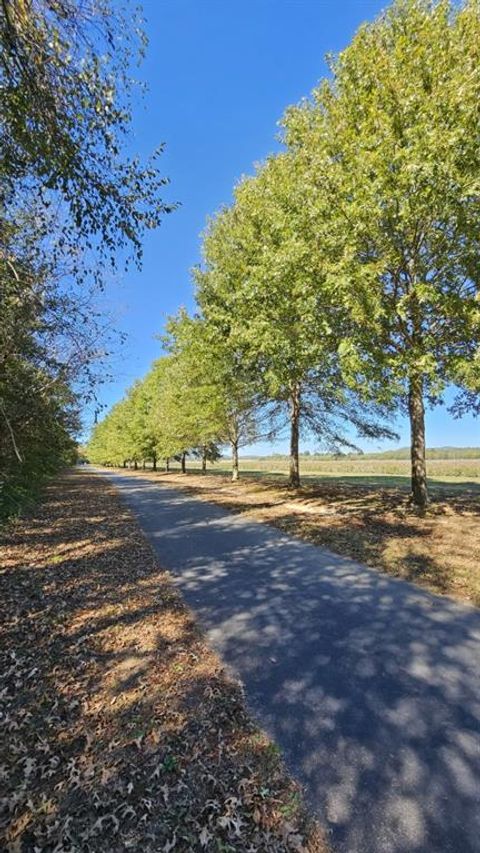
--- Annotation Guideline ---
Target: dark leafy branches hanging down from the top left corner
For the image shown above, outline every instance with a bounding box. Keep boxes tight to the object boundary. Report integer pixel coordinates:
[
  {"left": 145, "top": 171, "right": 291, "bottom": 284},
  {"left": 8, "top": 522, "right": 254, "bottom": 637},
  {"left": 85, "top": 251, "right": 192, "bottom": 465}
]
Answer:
[{"left": 0, "top": 0, "right": 170, "bottom": 280}]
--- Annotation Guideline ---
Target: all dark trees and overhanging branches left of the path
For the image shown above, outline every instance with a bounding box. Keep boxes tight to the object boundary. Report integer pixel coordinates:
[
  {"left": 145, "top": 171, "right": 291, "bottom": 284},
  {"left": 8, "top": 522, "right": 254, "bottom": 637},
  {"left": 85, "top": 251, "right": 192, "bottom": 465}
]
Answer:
[{"left": 0, "top": 0, "right": 168, "bottom": 517}]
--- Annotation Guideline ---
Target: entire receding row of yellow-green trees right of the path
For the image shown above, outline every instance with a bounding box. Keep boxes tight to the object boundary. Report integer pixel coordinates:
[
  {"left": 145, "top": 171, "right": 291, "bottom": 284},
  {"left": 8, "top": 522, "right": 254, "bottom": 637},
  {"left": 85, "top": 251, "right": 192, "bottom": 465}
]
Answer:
[{"left": 91, "top": 0, "right": 480, "bottom": 509}]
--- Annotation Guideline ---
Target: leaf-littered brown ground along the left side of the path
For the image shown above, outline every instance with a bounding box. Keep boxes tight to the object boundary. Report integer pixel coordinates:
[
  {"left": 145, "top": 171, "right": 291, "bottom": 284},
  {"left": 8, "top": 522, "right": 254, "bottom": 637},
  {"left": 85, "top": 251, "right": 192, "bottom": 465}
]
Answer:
[{"left": 0, "top": 473, "right": 325, "bottom": 853}]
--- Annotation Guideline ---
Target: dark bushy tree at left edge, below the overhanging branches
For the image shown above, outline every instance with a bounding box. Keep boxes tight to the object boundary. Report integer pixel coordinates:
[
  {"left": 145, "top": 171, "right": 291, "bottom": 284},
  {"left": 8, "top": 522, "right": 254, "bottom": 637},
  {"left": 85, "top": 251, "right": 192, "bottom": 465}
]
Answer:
[{"left": 0, "top": 209, "right": 89, "bottom": 516}]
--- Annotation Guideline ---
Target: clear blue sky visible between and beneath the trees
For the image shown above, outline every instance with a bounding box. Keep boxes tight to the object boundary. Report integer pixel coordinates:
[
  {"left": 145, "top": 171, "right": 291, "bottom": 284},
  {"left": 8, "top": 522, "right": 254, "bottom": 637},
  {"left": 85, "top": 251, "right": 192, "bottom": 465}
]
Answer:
[{"left": 92, "top": 0, "right": 480, "bottom": 452}]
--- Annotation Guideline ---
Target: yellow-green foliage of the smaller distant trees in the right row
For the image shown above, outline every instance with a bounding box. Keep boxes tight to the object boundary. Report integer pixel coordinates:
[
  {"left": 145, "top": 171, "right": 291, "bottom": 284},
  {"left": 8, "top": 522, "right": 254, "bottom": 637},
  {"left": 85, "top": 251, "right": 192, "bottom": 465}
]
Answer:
[{"left": 87, "top": 311, "right": 262, "bottom": 476}]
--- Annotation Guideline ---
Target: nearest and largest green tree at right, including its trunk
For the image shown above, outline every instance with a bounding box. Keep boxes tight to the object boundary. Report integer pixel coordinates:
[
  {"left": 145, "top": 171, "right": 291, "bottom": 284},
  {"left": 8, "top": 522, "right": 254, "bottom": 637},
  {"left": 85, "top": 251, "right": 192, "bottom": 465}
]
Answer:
[{"left": 285, "top": 0, "right": 480, "bottom": 511}]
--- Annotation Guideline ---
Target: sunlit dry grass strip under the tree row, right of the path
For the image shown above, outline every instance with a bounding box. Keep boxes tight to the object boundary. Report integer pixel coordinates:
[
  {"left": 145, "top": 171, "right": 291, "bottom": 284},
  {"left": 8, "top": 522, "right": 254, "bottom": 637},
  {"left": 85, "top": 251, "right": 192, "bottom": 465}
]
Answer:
[{"left": 118, "top": 471, "right": 480, "bottom": 606}]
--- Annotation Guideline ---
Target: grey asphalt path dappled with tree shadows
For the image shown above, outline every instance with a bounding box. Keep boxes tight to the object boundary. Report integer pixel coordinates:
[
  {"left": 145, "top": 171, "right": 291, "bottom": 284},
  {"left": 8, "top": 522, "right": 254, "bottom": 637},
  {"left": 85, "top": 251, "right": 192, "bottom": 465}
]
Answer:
[{"left": 97, "top": 474, "right": 480, "bottom": 853}]
